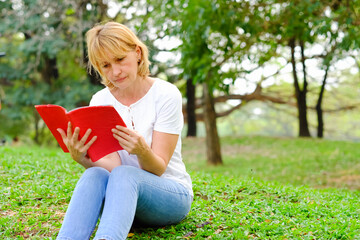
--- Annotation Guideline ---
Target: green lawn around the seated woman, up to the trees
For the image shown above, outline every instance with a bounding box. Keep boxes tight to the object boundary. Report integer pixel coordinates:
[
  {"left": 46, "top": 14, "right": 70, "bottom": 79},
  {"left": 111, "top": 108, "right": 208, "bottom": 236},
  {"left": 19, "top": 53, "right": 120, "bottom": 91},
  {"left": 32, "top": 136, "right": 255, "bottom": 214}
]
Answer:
[{"left": 0, "top": 137, "right": 360, "bottom": 239}]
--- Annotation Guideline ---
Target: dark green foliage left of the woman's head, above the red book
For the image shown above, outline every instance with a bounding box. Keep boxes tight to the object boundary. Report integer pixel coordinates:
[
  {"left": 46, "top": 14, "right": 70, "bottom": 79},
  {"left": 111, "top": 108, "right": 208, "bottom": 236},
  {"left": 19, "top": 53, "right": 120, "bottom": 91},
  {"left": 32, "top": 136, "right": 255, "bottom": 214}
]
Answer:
[{"left": 0, "top": 0, "right": 109, "bottom": 143}]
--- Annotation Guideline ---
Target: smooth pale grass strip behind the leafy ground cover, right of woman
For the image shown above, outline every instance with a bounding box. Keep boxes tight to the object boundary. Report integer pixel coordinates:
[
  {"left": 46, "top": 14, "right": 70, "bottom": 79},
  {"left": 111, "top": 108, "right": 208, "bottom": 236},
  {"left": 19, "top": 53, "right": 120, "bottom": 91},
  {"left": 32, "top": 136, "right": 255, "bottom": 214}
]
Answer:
[{"left": 183, "top": 137, "right": 360, "bottom": 190}]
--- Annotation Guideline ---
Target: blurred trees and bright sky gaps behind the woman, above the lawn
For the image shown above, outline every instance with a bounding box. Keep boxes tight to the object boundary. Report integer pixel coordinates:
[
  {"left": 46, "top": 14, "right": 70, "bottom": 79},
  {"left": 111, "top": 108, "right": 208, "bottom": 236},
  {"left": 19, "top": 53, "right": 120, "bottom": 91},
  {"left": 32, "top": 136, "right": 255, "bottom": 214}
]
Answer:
[{"left": 0, "top": 0, "right": 360, "bottom": 152}]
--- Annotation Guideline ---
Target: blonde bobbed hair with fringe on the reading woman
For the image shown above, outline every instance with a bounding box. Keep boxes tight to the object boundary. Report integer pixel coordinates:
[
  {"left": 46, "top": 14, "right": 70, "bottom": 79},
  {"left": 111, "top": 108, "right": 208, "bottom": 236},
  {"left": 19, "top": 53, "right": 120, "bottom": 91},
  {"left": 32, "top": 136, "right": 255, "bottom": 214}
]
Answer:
[{"left": 86, "top": 22, "right": 150, "bottom": 88}]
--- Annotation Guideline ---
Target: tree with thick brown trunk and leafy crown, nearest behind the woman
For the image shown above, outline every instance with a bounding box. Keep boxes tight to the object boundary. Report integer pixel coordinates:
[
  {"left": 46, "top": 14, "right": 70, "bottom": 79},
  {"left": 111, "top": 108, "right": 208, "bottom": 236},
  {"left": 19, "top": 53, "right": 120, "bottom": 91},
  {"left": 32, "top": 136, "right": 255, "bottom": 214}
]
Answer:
[{"left": 148, "top": 0, "right": 278, "bottom": 165}]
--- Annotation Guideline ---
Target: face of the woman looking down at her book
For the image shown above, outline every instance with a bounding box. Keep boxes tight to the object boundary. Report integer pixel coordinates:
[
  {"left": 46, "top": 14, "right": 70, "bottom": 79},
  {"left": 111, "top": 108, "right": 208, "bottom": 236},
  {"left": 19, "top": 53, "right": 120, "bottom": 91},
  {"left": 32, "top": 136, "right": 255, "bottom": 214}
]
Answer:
[{"left": 100, "top": 47, "right": 141, "bottom": 89}]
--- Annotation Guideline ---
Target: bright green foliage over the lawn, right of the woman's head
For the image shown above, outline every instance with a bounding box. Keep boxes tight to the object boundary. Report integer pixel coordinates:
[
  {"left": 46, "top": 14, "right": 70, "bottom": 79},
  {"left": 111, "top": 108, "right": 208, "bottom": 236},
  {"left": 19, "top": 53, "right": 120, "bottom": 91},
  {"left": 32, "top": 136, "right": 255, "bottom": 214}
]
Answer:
[{"left": 148, "top": 0, "right": 360, "bottom": 139}]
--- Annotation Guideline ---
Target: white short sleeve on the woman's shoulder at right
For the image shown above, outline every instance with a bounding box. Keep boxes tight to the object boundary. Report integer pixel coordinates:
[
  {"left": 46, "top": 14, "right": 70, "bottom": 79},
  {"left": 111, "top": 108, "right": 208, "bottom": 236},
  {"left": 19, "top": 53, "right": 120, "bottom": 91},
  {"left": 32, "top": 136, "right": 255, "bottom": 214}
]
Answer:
[{"left": 154, "top": 85, "right": 184, "bottom": 135}]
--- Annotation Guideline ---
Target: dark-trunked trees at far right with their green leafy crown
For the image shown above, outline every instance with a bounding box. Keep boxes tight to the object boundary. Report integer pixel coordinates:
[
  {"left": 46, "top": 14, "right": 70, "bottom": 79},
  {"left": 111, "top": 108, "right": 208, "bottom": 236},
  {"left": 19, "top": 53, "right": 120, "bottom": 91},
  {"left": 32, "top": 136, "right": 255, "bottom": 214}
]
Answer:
[{"left": 265, "top": 0, "right": 359, "bottom": 137}]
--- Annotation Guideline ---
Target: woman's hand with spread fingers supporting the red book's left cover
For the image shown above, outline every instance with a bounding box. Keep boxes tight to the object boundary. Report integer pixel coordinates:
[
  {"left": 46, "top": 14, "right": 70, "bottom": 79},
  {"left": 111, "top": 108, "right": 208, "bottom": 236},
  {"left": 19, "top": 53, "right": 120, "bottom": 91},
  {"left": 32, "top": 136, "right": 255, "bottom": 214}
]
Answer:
[{"left": 57, "top": 122, "right": 97, "bottom": 168}]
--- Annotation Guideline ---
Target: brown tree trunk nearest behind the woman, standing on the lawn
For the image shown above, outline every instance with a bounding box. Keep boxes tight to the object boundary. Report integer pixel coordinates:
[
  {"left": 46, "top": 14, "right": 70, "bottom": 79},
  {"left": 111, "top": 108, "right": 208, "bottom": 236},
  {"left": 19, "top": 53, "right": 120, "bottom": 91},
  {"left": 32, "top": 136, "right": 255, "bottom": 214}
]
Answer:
[{"left": 203, "top": 83, "right": 223, "bottom": 165}]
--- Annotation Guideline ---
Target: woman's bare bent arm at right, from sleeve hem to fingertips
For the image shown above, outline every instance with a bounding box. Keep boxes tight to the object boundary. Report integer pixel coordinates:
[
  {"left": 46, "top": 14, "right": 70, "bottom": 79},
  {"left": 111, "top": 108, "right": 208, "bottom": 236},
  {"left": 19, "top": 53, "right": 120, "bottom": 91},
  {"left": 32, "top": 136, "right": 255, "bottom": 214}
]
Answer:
[{"left": 113, "top": 126, "right": 179, "bottom": 176}]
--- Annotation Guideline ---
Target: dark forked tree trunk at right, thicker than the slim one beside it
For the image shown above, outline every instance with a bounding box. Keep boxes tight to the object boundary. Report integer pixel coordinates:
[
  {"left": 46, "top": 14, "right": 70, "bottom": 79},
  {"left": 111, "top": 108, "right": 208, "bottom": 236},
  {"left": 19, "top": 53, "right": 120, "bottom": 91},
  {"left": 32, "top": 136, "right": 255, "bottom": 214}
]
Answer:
[{"left": 289, "top": 38, "right": 311, "bottom": 137}]
